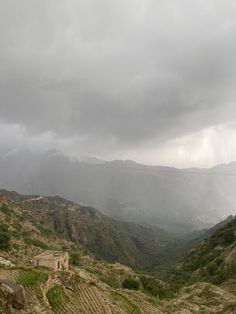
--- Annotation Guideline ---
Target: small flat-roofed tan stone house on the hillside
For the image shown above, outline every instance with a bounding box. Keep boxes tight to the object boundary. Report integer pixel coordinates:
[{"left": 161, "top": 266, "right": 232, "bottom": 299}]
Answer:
[{"left": 33, "top": 251, "right": 69, "bottom": 270}]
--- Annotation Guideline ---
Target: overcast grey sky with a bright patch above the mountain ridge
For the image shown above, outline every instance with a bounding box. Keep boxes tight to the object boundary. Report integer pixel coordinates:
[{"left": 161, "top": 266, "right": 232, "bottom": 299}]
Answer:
[{"left": 0, "top": 0, "right": 236, "bottom": 167}]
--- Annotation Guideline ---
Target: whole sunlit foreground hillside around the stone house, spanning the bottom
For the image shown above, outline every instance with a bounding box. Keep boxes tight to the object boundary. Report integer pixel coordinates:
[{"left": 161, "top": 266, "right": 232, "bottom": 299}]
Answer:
[{"left": 0, "top": 192, "right": 236, "bottom": 314}]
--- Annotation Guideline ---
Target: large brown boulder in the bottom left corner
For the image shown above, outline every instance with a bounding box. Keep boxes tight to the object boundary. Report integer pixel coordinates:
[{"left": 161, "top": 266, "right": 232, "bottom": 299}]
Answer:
[{"left": 0, "top": 280, "right": 26, "bottom": 309}]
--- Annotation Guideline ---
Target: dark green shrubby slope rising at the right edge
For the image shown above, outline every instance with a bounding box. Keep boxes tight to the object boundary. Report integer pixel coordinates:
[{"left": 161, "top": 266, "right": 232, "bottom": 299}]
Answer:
[{"left": 170, "top": 218, "right": 236, "bottom": 286}]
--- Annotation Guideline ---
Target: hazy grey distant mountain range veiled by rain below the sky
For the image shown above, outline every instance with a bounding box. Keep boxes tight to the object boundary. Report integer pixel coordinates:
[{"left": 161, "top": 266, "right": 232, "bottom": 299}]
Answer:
[{"left": 0, "top": 151, "right": 236, "bottom": 233}]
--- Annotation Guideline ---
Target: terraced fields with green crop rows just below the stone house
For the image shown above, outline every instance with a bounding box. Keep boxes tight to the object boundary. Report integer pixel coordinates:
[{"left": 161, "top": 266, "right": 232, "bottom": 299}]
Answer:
[{"left": 0, "top": 269, "right": 165, "bottom": 314}]
